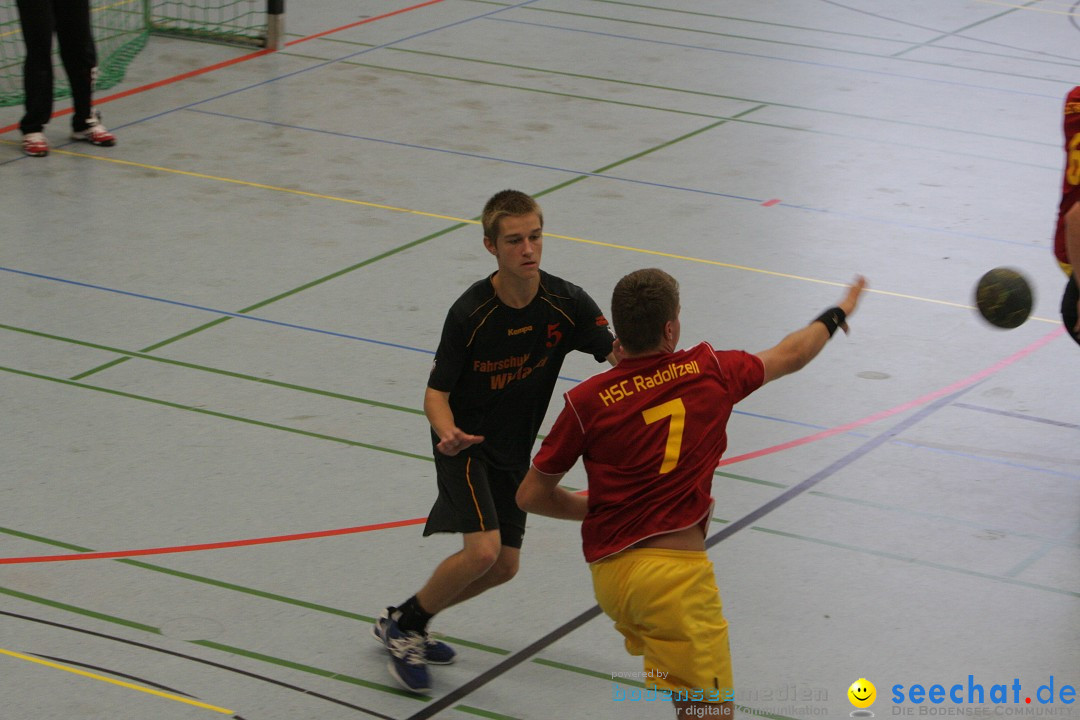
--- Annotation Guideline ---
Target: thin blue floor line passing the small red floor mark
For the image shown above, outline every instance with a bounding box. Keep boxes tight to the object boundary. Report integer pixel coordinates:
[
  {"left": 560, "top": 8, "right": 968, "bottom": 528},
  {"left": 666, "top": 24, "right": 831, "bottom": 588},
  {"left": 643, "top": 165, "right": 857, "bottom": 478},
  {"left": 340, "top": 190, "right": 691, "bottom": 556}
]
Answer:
[{"left": 186, "top": 108, "right": 1056, "bottom": 253}]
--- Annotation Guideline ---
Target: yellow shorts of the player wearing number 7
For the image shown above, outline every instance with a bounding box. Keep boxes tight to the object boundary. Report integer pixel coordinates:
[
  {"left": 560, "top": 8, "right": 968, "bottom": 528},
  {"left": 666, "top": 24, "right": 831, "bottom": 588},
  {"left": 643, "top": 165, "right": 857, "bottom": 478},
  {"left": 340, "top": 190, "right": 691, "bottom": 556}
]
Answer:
[{"left": 590, "top": 547, "right": 734, "bottom": 703}]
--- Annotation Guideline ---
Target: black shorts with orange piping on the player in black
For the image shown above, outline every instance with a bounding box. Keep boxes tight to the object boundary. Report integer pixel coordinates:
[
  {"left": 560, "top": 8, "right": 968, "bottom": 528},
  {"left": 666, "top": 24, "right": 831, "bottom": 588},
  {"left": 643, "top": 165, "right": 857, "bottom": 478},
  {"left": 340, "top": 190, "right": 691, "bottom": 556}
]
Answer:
[{"left": 423, "top": 450, "right": 526, "bottom": 548}]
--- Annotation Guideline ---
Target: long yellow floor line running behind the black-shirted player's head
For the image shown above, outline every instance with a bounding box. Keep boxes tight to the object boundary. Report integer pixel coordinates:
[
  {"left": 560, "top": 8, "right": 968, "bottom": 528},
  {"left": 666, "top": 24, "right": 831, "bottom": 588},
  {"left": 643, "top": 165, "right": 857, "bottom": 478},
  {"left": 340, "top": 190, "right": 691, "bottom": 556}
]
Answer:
[{"left": 6, "top": 140, "right": 1058, "bottom": 324}]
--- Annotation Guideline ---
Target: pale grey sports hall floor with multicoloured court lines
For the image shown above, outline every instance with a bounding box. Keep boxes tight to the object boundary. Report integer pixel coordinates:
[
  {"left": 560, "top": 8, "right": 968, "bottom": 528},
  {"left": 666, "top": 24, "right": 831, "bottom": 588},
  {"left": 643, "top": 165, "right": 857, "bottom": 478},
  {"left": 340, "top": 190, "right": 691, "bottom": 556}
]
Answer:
[{"left": 0, "top": 0, "right": 1080, "bottom": 720}]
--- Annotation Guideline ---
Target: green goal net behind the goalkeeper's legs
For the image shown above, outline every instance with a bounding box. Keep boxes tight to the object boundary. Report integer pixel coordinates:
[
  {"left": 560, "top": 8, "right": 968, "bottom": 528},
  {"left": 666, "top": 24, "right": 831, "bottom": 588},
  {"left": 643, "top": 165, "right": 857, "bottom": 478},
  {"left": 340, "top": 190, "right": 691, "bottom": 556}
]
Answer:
[{"left": 0, "top": 0, "right": 284, "bottom": 107}]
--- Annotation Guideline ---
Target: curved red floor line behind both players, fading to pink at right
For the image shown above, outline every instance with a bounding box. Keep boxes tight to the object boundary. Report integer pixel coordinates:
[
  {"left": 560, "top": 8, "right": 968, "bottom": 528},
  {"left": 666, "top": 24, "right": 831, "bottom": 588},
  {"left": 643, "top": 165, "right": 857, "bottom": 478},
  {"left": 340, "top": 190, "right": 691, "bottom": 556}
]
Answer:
[{"left": 0, "top": 326, "right": 1065, "bottom": 565}]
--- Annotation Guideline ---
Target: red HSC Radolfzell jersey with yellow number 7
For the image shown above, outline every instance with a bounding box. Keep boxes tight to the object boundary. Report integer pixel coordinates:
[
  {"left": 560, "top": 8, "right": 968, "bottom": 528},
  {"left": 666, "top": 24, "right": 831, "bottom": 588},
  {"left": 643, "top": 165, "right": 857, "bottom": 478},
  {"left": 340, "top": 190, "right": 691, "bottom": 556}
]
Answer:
[{"left": 532, "top": 342, "right": 765, "bottom": 562}]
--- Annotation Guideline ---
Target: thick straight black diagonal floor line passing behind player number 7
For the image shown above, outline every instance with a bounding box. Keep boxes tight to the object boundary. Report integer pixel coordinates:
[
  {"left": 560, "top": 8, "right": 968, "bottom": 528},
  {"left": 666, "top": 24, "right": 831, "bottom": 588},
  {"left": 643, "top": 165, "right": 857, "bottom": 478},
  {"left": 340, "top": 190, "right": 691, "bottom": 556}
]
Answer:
[{"left": 405, "top": 381, "right": 982, "bottom": 720}]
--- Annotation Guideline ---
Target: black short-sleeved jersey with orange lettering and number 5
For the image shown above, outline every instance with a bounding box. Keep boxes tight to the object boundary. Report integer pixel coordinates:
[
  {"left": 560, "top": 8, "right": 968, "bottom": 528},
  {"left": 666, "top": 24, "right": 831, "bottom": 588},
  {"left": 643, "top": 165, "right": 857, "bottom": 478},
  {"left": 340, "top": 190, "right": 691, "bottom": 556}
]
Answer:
[{"left": 428, "top": 271, "right": 613, "bottom": 470}]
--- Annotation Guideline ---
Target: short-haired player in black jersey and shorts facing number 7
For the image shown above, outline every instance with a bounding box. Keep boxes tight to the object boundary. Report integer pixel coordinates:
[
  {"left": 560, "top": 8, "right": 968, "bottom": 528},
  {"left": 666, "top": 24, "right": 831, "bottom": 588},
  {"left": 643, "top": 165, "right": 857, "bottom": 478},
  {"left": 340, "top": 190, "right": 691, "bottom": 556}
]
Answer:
[{"left": 373, "top": 190, "right": 616, "bottom": 692}]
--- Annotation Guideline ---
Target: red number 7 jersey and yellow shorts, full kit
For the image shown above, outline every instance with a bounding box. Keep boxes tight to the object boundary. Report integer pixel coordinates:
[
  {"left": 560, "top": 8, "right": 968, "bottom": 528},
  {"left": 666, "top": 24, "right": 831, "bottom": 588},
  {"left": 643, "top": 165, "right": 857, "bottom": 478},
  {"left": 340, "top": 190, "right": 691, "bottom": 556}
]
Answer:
[{"left": 532, "top": 342, "right": 765, "bottom": 703}]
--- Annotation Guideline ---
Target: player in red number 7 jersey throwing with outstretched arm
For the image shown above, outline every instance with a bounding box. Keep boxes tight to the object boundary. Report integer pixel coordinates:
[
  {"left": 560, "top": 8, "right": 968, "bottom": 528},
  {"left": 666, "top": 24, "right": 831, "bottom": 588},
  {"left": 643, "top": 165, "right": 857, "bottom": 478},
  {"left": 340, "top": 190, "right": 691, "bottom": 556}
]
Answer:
[{"left": 517, "top": 269, "right": 866, "bottom": 718}]
